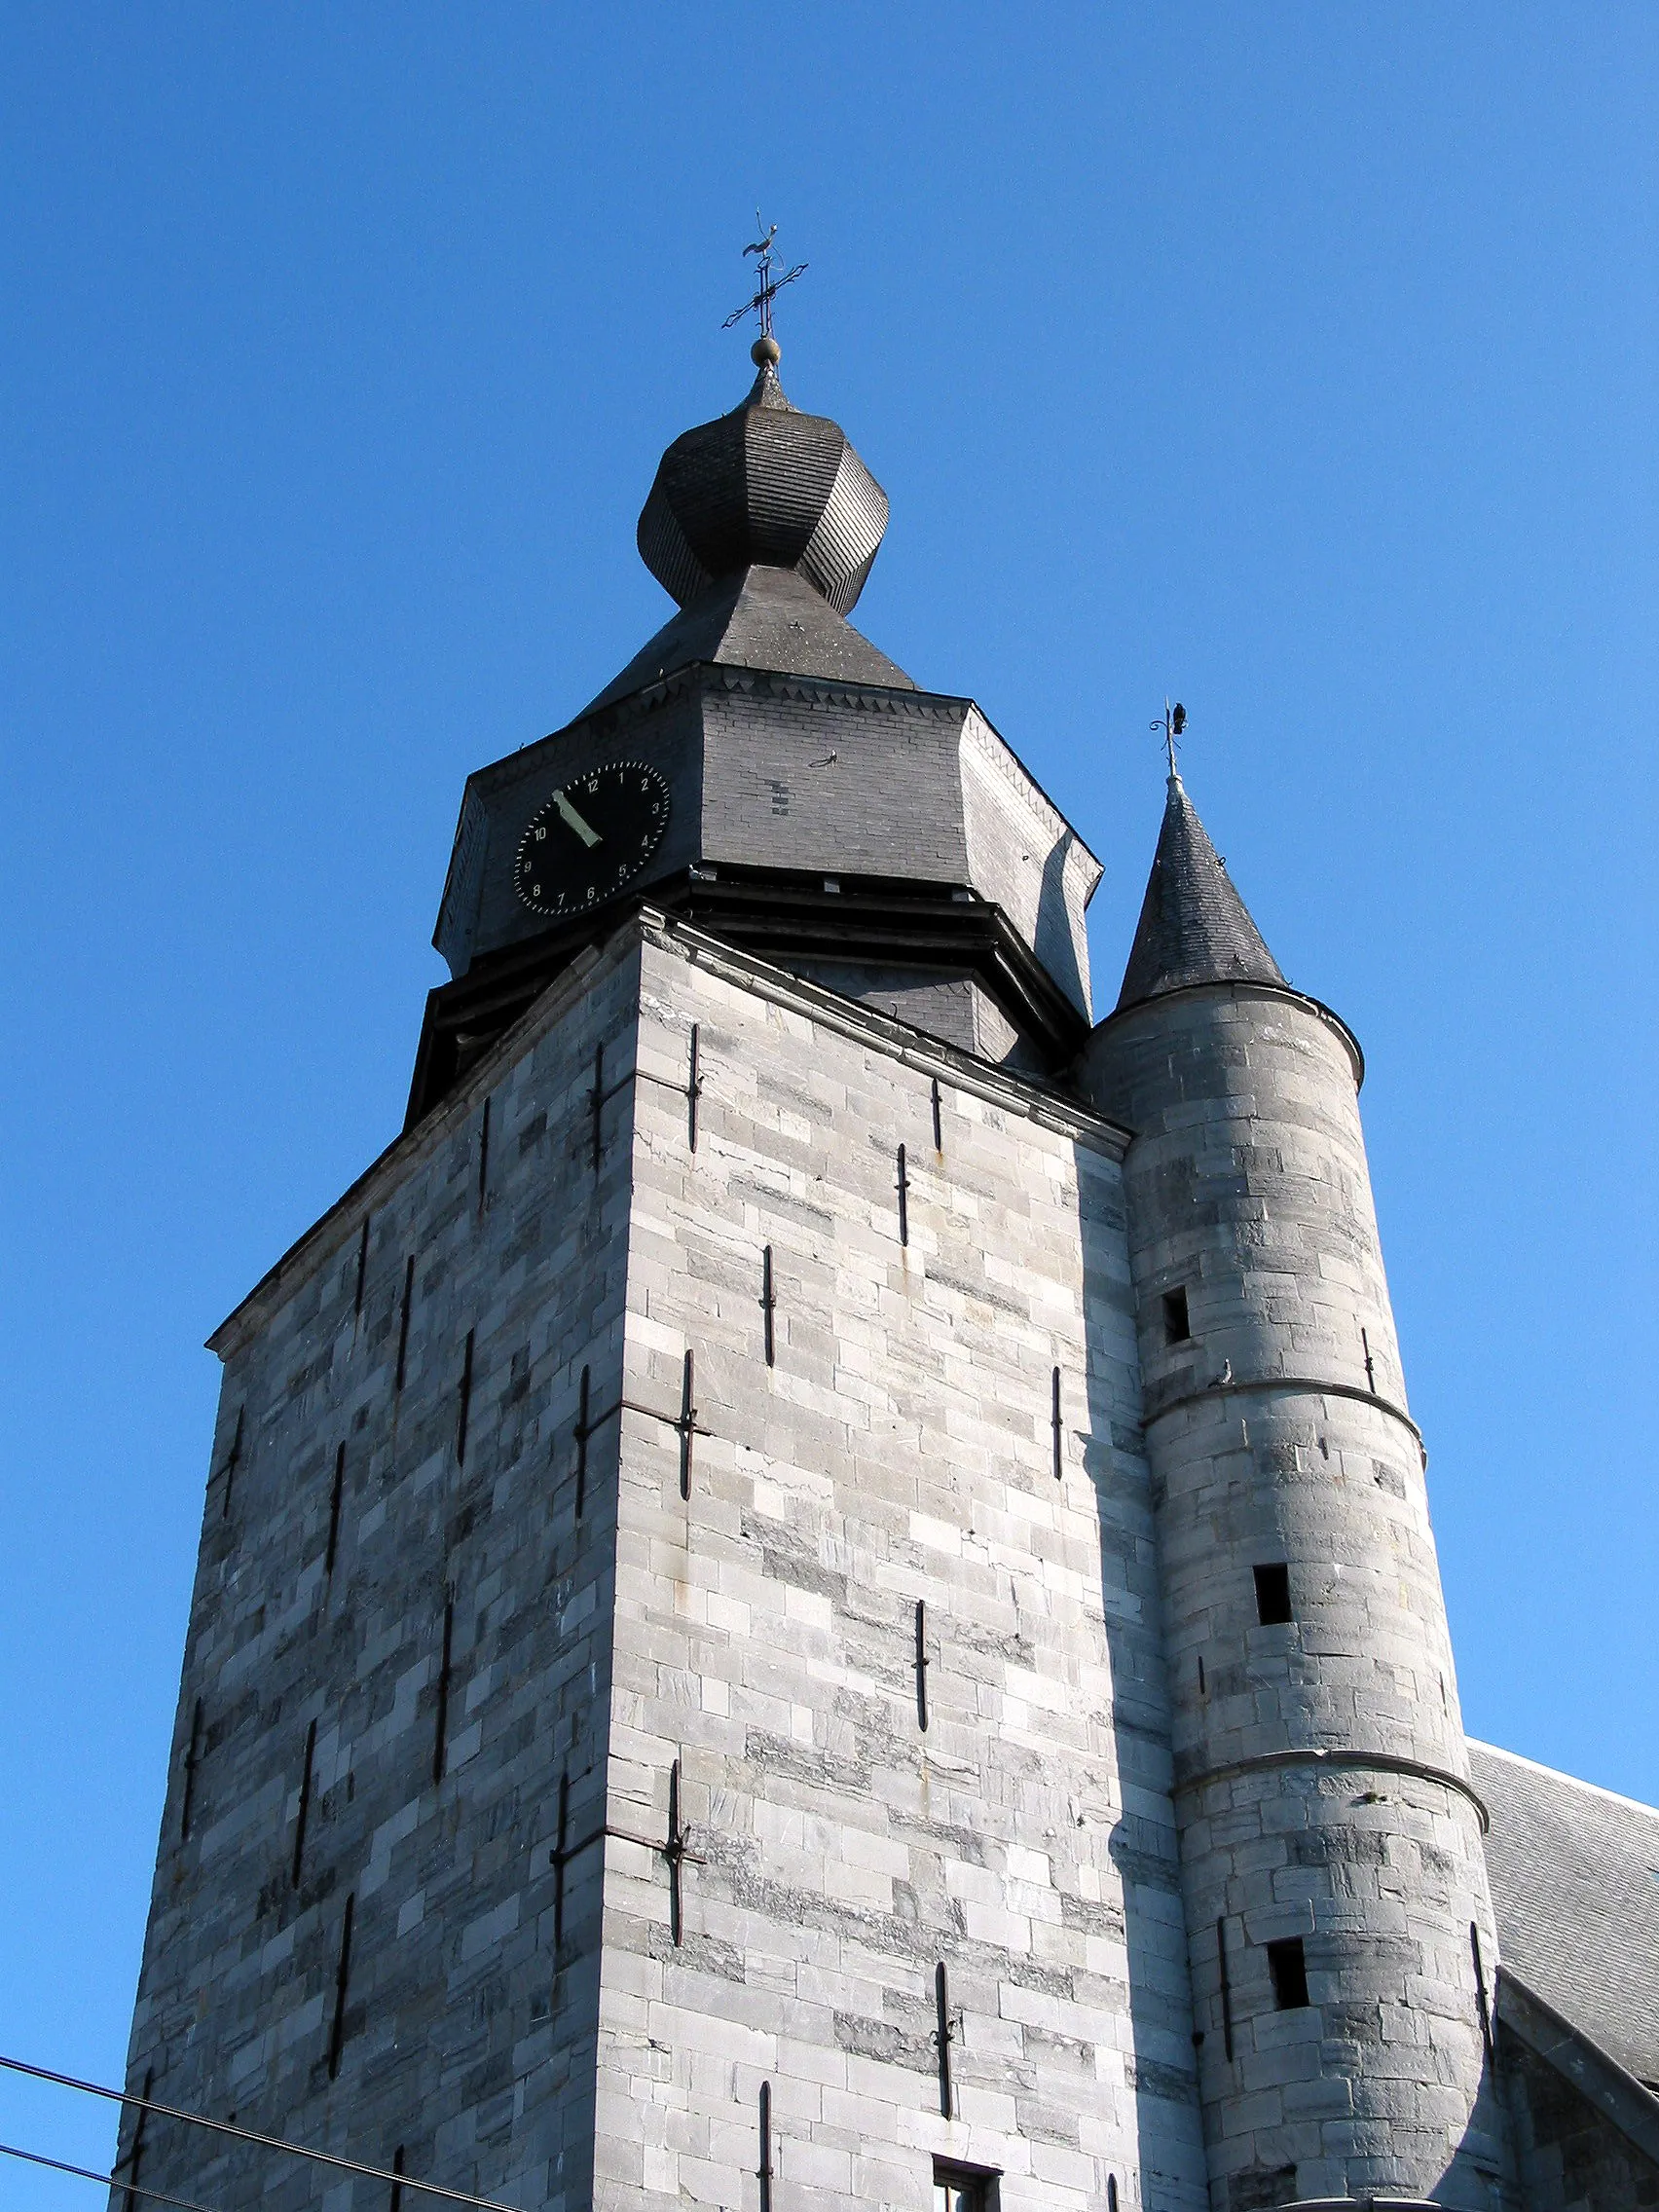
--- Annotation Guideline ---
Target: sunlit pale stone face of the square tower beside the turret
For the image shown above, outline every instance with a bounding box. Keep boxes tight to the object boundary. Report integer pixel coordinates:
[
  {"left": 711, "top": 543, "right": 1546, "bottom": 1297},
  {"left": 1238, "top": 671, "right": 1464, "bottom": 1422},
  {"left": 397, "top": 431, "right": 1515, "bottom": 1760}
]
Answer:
[{"left": 597, "top": 932, "right": 1203, "bottom": 2212}]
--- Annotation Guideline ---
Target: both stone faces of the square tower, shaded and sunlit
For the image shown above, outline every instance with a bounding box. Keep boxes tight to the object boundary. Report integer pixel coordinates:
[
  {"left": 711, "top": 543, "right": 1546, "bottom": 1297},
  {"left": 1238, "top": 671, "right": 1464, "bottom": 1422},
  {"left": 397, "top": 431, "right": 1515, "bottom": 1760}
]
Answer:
[{"left": 113, "top": 913, "right": 1212, "bottom": 2212}]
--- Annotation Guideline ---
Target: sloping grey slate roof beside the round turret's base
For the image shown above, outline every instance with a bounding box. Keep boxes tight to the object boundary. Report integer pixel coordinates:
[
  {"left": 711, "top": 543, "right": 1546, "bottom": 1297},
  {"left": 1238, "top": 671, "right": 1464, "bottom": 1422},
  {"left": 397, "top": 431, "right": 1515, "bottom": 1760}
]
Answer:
[{"left": 1469, "top": 1743, "right": 1659, "bottom": 2085}]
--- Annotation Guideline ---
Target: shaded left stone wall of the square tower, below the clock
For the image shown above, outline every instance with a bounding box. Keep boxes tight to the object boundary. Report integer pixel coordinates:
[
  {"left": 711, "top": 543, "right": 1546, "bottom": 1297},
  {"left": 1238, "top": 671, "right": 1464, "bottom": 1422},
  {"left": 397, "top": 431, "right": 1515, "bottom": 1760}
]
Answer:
[{"left": 111, "top": 958, "right": 637, "bottom": 2212}]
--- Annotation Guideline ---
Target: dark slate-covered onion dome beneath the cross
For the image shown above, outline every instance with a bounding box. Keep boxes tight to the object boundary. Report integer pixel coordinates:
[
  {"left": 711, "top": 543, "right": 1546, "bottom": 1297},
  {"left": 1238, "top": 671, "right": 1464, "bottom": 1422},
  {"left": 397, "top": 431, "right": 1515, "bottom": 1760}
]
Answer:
[{"left": 640, "top": 351, "right": 887, "bottom": 615}]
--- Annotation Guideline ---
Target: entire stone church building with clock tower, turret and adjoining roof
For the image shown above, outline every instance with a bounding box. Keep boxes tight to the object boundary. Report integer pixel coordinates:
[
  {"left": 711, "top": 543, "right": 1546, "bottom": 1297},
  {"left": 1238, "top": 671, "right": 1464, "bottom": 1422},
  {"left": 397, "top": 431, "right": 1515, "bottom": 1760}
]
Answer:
[{"left": 113, "top": 315, "right": 1659, "bottom": 2212}]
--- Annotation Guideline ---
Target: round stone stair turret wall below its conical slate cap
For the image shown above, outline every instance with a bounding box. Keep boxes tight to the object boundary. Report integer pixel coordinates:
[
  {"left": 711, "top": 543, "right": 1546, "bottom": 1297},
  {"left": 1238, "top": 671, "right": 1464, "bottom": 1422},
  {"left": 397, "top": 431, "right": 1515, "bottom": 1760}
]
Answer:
[{"left": 1084, "top": 984, "right": 1499, "bottom": 2212}]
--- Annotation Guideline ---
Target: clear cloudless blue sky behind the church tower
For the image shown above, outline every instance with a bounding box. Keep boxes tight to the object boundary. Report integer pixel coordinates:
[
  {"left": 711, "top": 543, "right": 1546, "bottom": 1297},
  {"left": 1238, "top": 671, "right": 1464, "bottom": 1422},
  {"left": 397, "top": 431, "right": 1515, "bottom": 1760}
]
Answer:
[{"left": 0, "top": 0, "right": 1659, "bottom": 2212}]
